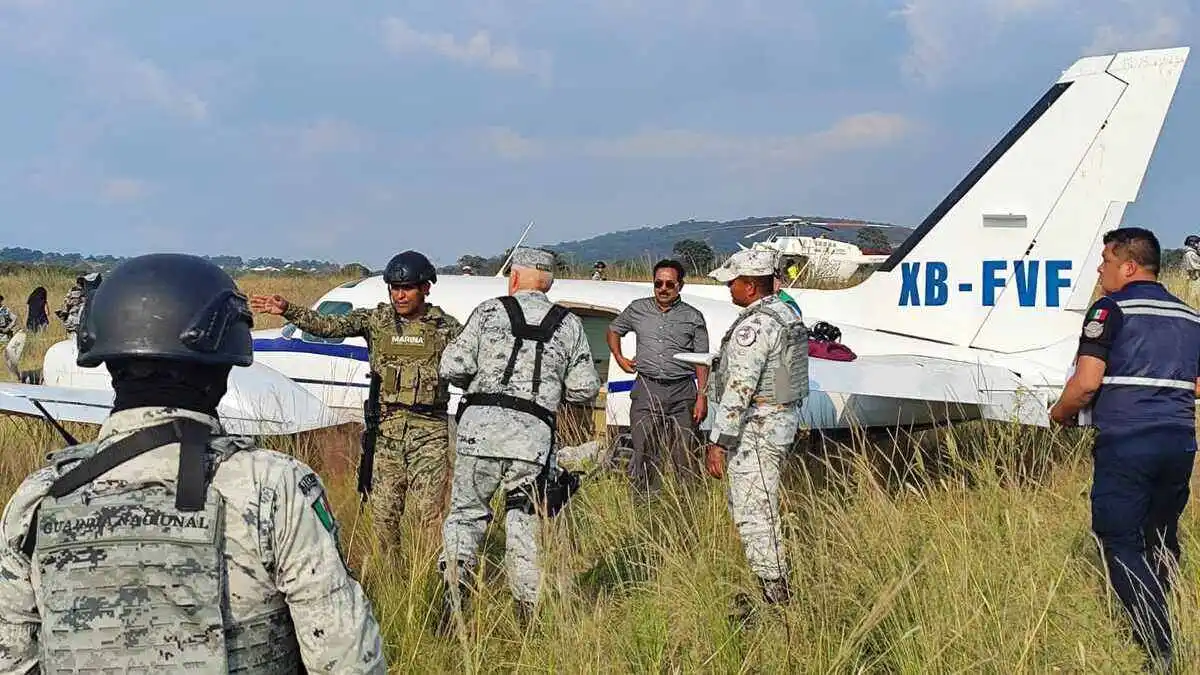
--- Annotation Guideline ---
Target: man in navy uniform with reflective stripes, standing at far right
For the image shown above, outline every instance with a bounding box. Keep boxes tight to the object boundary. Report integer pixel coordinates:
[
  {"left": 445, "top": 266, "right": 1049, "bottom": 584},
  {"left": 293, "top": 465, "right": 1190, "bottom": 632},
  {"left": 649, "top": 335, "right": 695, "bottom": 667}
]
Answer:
[{"left": 1050, "top": 227, "right": 1200, "bottom": 663}]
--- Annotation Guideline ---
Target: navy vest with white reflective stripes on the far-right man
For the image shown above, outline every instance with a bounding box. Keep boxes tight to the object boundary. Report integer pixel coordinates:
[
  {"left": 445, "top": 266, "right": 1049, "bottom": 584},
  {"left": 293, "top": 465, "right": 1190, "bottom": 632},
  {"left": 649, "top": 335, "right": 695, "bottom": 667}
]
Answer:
[{"left": 1087, "top": 281, "right": 1200, "bottom": 442}]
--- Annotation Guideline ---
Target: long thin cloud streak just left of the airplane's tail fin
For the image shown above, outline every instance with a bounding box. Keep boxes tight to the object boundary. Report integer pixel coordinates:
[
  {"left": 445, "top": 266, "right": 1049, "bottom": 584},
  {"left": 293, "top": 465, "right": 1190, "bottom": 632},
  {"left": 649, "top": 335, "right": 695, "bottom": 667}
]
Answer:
[{"left": 472, "top": 113, "right": 914, "bottom": 166}]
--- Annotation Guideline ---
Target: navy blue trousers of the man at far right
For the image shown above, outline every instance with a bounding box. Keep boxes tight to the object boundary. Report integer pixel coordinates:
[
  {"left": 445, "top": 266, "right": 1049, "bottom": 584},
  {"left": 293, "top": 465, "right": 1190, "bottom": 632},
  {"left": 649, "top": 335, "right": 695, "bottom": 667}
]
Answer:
[{"left": 1091, "top": 434, "right": 1195, "bottom": 656}]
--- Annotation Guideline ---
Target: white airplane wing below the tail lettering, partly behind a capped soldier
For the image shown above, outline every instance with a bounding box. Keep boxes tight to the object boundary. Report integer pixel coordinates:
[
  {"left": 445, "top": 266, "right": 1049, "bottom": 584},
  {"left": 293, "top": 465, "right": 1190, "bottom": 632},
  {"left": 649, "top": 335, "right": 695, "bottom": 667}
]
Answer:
[{"left": 674, "top": 345, "right": 1050, "bottom": 428}]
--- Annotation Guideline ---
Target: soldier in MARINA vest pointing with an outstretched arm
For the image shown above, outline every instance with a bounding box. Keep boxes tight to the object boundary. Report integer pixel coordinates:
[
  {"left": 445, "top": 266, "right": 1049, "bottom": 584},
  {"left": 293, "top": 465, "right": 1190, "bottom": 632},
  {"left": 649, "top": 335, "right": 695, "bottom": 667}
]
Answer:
[{"left": 251, "top": 251, "right": 462, "bottom": 545}]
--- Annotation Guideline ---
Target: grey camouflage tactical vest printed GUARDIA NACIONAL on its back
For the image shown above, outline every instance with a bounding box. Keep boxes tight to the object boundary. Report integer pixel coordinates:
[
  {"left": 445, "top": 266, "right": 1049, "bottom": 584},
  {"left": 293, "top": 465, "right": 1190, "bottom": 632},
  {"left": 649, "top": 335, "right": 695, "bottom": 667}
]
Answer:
[{"left": 24, "top": 420, "right": 302, "bottom": 675}]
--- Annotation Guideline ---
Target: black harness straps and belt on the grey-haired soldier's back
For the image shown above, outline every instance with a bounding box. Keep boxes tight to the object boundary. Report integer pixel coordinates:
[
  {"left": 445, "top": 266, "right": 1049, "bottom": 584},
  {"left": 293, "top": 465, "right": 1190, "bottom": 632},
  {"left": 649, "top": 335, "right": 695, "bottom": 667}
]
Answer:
[{"left": 455, "top": 295, "right": 570, "bottom": 435}]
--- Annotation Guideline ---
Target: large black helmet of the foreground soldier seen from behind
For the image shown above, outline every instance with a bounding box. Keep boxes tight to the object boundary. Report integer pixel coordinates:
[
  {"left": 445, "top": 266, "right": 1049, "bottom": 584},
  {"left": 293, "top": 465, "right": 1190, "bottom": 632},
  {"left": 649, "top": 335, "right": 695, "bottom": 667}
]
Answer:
[{"left": 76, "top": 253, "right": 254, "bottom": 368}]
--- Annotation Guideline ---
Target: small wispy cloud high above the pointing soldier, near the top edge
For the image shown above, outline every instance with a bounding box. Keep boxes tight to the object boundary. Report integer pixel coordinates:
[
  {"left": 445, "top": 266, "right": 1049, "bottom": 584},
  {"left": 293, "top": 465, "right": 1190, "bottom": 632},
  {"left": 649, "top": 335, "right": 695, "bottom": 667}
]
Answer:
[{"left": 383, "top": 17, "right": 551, "bottom": 80}]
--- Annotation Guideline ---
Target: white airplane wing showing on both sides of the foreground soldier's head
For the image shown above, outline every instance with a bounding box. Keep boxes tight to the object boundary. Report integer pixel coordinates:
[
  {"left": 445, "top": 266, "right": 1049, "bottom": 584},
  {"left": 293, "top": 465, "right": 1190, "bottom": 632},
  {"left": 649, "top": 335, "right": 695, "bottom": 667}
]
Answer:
[{"left": 0, "top": 364, "right": 340, "bottom": 436}]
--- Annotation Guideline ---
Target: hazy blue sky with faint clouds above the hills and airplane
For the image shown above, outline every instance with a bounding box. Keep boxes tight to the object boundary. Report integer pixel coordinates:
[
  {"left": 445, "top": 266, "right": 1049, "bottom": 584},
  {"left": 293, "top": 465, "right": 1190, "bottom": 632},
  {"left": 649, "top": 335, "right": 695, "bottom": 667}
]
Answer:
[{"left": 0, "top": 0, "right": 1200, "bottom": 267}]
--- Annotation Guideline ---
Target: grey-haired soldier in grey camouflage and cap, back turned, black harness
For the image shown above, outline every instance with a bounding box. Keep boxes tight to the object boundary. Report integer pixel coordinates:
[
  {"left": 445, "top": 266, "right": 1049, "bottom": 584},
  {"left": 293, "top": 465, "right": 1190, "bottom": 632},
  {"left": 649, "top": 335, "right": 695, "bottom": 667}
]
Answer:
[{"left": 439, "top": 247, "right": 600, "bottom": 619}]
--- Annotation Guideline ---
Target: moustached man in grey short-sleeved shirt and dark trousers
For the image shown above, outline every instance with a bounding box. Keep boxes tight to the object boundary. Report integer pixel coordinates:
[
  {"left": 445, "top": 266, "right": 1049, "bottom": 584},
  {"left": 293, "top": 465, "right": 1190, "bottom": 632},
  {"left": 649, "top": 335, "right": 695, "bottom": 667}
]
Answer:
[{"left": 607, "top": 259, "right": 708, "bottom": 490}]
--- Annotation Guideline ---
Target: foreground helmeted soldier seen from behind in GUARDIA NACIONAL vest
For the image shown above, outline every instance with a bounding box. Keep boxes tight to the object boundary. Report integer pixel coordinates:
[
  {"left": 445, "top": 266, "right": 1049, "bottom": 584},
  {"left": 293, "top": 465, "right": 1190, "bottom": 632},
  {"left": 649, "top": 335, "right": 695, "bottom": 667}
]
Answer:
[{"left": 0, "top": 255, "right": 385, "bottom": 674}]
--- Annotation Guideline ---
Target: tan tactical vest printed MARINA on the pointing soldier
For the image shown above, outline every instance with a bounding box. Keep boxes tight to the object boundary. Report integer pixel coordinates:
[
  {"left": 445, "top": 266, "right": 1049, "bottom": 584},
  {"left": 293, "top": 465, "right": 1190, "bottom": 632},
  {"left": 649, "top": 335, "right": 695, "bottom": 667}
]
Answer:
[{"left": 376, "top": 309, "right": 449, "bottom": 412}]
